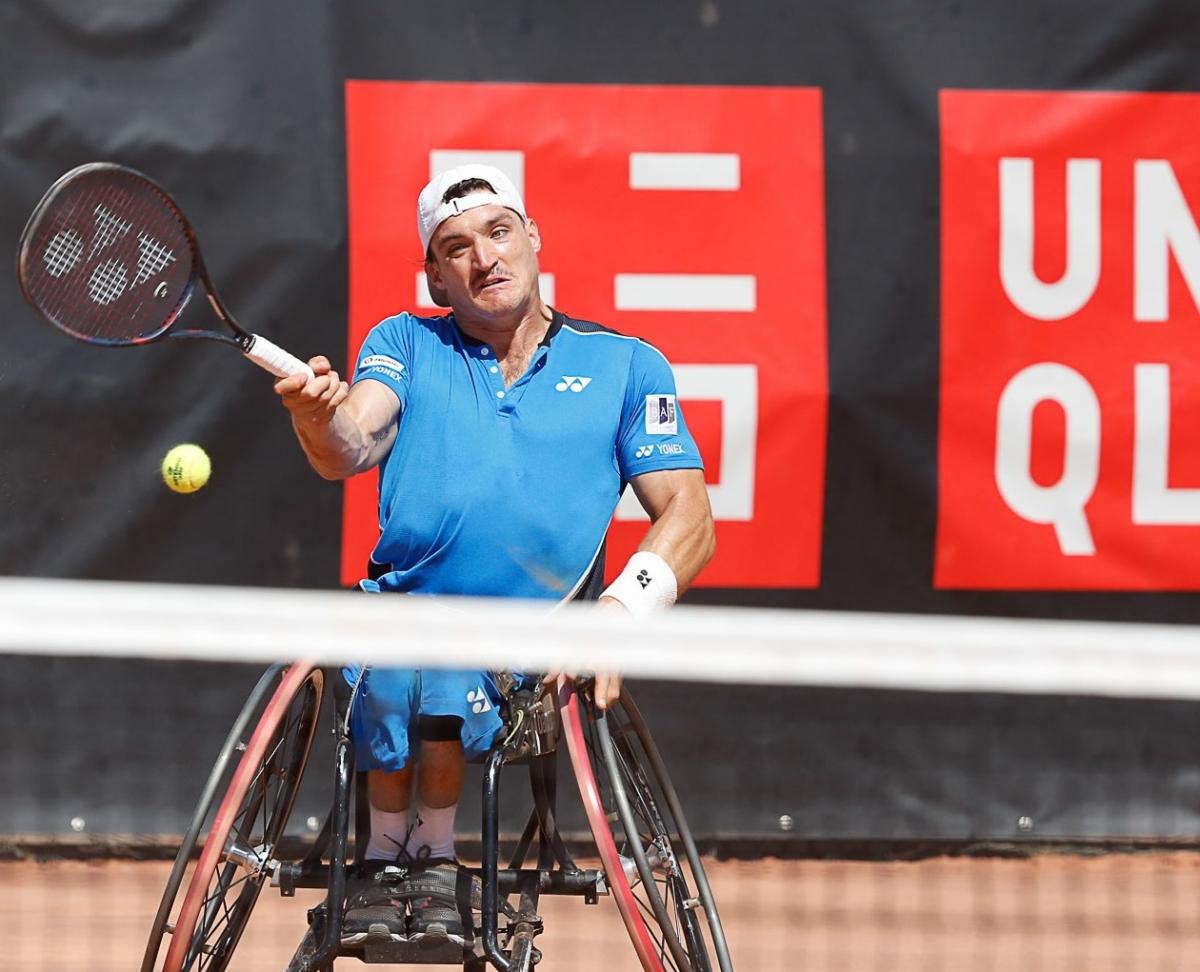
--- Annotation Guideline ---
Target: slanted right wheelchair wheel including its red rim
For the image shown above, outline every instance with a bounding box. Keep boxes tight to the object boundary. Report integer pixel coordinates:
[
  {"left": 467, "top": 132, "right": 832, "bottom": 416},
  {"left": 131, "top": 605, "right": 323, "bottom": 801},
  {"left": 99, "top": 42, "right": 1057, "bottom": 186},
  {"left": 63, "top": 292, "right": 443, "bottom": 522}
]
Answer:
[{"left": 562, "top": 689, "right": 733, "bottom": 972}]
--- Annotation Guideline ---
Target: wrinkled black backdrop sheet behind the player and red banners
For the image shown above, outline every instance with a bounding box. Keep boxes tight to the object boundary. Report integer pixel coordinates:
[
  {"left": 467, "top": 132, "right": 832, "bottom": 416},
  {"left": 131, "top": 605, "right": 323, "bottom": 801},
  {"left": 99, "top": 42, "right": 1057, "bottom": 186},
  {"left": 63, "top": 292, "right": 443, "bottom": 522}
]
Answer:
[{"left": 0, "top": 0, "right": 1200, "bottom": 835}]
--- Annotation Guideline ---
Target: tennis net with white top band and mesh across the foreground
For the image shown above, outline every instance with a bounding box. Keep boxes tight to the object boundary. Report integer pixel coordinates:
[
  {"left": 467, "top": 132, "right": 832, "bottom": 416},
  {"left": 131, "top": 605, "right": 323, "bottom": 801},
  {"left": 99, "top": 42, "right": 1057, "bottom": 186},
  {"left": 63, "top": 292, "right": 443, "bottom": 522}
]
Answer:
[{"left": 0, "top": 578, "right": 1200, "bottom": 972}]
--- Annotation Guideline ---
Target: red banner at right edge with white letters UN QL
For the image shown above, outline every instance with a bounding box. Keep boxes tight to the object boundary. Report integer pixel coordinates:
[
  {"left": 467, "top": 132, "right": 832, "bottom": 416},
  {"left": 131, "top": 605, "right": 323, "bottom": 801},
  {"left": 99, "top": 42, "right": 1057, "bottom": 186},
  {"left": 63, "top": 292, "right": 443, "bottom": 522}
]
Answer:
[{"left": 935, "top": 91, "right": 1200, "bottom": 590}]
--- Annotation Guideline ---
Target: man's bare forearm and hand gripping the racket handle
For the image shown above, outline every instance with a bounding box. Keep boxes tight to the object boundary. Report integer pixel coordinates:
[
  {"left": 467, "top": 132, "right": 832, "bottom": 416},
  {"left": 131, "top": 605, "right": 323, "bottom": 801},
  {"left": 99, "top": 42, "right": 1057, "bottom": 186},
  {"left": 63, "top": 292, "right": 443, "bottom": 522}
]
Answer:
[{"left": 275, "top": 355, "right": 400, "bottom": 479}]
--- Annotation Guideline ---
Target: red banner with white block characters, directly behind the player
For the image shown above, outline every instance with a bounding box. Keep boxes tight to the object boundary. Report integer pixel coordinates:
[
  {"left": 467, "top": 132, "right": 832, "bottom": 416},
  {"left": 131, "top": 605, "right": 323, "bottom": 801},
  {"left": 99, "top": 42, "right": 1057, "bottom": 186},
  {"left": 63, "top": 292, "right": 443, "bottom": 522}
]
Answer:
[{"left": 342, "top": 82, "right": 827, "bottom": 588}]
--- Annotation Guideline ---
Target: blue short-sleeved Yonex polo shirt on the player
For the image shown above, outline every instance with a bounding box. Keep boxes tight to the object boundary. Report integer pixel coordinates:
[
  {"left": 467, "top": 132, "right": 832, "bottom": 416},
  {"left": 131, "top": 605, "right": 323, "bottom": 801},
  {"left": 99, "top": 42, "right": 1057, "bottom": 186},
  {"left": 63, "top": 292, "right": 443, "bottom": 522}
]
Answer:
[{"left": 354, "top": 311, "right": 703, "bottom": 599}]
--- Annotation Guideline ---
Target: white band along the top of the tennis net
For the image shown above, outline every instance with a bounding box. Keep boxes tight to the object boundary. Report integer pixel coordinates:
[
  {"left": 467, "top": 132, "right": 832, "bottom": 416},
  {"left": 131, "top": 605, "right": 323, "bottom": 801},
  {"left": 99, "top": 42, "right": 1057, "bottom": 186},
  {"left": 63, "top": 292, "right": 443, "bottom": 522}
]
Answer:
[{"left": 0, "top": 577, "right": 1200, "bottom": 698}]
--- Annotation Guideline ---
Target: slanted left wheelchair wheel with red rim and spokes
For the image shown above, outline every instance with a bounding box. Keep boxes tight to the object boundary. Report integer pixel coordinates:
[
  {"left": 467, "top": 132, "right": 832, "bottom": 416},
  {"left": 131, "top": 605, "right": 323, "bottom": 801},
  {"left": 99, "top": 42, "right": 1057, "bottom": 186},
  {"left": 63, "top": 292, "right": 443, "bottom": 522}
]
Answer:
[{"left": 160, "top": 664, "right": 324, "bottom": 972}]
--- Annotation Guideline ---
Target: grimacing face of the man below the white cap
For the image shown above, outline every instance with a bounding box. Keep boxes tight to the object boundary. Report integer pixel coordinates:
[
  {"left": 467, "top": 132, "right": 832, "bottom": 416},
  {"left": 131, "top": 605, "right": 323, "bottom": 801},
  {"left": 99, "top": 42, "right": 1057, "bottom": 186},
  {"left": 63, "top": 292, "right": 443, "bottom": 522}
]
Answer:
[{"left": 425, "top": 204, "right": 541, "bottom": 319}]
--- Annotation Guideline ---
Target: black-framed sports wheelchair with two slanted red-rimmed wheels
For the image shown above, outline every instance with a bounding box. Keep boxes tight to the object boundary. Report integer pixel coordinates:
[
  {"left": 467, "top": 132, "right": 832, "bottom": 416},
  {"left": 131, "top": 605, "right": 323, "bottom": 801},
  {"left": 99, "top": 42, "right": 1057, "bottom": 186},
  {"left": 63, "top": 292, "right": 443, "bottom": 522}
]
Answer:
[{"left": 142, "top": 662, "right": 733, "bottom": 972}]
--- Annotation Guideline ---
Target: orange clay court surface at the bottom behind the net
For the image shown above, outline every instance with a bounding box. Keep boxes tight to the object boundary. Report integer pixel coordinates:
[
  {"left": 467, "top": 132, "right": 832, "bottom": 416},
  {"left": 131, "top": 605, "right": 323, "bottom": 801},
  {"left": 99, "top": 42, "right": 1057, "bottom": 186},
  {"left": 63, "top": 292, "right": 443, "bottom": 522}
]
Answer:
[{"left": 7, "top": 853, "right": 1200, "bottom": 972}]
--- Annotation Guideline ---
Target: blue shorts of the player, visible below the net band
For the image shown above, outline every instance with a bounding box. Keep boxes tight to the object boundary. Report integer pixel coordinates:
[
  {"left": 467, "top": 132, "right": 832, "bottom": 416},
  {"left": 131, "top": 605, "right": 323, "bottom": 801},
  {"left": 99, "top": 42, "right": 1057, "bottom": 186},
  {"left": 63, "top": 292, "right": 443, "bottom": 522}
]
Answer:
[{"left": 342, "top": 665, "right": 503, "bottom": 772}]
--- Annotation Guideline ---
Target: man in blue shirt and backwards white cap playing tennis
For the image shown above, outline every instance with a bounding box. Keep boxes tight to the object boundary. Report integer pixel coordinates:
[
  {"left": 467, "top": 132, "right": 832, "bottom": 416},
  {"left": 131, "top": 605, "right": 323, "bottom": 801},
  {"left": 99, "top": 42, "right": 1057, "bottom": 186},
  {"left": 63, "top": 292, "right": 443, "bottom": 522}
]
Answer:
[{"left": 275, "top": 164, "right": 715, "bottom": 941}]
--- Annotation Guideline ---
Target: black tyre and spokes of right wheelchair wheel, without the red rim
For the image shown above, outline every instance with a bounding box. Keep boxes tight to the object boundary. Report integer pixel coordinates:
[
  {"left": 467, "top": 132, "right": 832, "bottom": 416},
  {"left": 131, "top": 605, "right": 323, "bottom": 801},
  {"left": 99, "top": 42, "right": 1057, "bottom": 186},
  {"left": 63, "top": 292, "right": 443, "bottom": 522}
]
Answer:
[{"left": 586, "top": 689, "right": 733, "bottom": 972}]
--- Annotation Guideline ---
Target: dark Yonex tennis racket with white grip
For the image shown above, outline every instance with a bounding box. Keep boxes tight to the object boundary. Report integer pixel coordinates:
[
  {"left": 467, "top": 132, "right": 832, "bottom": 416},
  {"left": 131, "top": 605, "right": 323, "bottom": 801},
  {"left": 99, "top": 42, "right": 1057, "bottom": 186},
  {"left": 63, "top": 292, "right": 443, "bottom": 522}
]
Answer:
[{"left": 17, "top": 162, "right": 312, "bottom": 378}]
